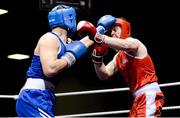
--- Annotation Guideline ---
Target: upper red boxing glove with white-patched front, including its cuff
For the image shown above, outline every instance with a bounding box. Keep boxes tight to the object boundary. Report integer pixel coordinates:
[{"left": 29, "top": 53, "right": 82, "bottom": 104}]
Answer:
[{"left": 77, "top": 21, "right": 104, "bottom": 44}]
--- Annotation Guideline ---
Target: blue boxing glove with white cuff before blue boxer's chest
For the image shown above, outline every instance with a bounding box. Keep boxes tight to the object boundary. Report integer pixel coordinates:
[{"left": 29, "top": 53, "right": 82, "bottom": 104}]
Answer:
[{"left": 61, "top": 41, "right": 87, "bottom": 67}]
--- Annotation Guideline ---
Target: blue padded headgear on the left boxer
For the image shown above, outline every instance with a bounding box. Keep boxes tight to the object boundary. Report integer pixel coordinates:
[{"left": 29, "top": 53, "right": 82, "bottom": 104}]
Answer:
[{"left": 48, "top": 5, "right": 76, "bottom": 35}]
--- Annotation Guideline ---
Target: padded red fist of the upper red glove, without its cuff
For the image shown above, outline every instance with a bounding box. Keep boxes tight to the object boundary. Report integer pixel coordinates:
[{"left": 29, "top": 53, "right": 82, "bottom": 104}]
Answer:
[{"left": 77, "top": 21, "right": 97, "bottom": 40}]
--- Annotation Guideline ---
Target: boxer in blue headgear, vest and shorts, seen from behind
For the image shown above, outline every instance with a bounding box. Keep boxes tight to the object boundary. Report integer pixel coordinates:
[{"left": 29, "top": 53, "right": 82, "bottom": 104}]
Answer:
[{"left": 16, "top": 5, "right": 94, "bottom": 117}]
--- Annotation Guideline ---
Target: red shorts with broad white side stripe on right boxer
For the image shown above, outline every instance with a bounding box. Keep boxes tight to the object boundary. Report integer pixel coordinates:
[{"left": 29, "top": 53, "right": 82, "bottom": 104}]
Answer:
[{"left": 129, "top": 82, "right": 165, "bottom": 117}]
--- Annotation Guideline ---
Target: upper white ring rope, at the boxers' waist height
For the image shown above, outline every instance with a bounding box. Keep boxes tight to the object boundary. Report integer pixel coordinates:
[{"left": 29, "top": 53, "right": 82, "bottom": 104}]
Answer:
[{"left": 0, "top": 82, "right": 180, "bottom": 99}]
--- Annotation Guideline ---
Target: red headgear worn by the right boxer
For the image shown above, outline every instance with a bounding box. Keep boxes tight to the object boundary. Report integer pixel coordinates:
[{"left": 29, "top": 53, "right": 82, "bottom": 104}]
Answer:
[{"left": 115, "top": 18, "right": 131, "bottom": 39}]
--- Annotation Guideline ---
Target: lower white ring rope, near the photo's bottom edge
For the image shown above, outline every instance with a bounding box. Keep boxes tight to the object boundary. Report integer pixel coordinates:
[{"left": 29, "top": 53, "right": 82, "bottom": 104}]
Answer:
[{"left": 59, "top": 106, "right": 180, "bottom": 117}]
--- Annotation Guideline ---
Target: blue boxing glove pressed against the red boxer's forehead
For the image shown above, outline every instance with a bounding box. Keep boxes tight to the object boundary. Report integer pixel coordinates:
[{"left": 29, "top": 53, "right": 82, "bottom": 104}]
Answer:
[{"left": 96, "top": 15, "right": 116, "bottom": 34}]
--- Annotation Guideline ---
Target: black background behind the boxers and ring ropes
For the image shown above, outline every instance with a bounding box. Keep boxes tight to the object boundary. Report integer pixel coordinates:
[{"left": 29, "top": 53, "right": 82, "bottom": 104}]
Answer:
[{"left": 0, "top": 0, "right": 180, "bottom": 117}]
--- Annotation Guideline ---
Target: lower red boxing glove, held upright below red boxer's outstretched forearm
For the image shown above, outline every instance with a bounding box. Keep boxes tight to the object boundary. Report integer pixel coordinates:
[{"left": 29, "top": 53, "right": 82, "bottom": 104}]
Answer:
[{"left": 91, "top": 44, "right": 109, "bottom": 64}]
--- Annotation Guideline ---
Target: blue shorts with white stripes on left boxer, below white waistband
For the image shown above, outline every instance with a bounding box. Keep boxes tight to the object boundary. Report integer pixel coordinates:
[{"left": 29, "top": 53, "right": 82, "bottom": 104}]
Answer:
[{"left": 16, "top": 89, "right": 55, "bottom": 117}]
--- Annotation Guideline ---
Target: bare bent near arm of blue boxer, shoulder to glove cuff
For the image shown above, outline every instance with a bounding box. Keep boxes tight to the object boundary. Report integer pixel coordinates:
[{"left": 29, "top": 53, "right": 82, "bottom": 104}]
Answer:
[{"left": 38, "top": 35, "right": 68, "bottom": 77}]
